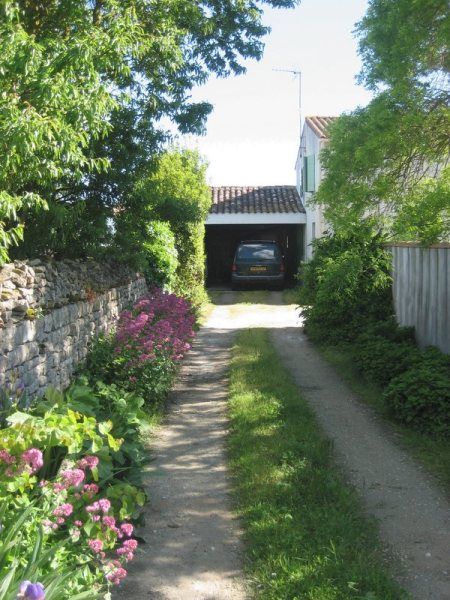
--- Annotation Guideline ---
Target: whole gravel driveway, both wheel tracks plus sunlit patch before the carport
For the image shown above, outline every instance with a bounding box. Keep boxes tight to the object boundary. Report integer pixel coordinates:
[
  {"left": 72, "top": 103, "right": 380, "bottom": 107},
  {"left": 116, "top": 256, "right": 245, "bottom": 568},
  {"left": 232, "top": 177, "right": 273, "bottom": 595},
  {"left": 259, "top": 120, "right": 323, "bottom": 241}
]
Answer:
[{"left": 118, "top": 292, "right": 450, "bottom": 600}]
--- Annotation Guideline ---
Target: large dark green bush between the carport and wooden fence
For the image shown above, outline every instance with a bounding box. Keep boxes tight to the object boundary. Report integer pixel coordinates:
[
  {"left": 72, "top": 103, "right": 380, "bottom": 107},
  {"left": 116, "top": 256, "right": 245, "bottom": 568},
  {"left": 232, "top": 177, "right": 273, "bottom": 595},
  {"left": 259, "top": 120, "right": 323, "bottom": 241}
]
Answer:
[{"left": 299, "top": 228, "right": 392, "bottom": 342}]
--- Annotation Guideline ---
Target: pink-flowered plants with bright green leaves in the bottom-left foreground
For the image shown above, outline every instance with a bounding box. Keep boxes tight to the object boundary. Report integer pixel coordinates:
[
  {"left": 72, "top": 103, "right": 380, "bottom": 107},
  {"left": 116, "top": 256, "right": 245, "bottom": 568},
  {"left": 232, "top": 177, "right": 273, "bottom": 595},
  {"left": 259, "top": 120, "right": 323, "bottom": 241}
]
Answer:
[{"left": 0, "top": 448, "right": 137, "bottom": 598}]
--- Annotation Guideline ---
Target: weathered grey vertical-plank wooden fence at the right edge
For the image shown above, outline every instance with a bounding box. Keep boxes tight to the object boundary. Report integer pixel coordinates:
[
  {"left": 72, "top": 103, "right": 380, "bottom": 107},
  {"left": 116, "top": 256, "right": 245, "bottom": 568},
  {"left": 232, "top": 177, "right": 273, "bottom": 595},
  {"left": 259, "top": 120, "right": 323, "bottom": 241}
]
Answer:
[{"left": 391, "top": 244, "right": 450, "bottom": 353}]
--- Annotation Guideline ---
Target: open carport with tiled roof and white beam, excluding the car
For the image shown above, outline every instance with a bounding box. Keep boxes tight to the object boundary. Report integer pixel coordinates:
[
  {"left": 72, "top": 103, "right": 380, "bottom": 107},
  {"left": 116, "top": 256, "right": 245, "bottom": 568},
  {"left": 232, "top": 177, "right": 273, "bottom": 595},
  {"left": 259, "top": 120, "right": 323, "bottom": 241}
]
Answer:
[{"left": 206, "top": 185, "right": 306, "bottom": 284}]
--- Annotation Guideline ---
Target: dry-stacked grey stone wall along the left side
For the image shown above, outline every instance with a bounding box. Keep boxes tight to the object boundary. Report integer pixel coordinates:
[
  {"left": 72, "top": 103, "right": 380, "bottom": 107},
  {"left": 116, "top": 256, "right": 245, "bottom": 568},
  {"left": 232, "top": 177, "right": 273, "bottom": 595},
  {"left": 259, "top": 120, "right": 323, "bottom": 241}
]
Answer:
[{"left": 0, "top": 260, "right": 147, "bottom": 395}]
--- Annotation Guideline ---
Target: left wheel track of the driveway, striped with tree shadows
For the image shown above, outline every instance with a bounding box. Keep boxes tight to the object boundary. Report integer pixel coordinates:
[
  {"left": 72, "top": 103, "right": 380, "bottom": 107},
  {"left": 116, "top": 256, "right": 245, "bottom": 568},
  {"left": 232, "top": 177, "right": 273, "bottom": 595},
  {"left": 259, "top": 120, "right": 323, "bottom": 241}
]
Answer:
[{"left": 114, "top": 325, "right": 245, "bottom": 600}]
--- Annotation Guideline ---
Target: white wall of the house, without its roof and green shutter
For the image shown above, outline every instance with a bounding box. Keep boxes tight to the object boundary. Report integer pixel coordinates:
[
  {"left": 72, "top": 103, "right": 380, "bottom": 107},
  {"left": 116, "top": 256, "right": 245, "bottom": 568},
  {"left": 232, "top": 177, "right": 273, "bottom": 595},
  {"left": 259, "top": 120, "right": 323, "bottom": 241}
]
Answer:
[{"left": 296, "top": 125, "right": 327, "bottom": 260}]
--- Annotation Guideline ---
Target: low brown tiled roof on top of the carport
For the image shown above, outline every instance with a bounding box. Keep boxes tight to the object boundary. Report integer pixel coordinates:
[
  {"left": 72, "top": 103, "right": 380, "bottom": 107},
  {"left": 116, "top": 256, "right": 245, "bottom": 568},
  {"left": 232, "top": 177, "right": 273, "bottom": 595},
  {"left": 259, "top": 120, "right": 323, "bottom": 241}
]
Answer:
[{"left": 209, "top": 185, "right": 305, "bottom": 215}]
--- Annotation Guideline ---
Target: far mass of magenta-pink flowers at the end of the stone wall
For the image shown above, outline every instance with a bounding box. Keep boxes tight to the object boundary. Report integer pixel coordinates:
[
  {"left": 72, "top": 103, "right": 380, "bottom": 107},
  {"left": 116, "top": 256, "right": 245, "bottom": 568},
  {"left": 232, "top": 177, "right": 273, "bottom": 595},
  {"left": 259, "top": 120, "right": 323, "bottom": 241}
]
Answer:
[{"left": 116, "top": 288, "right": 195, "bottom": 363}]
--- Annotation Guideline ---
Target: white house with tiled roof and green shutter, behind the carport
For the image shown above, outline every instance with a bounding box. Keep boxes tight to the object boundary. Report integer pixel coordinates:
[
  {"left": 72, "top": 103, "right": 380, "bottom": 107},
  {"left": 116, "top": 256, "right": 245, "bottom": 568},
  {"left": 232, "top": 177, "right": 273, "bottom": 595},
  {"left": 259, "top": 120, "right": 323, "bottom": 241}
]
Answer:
[{"left": 295, "top": 117, "right": 337, "bottom": 260}]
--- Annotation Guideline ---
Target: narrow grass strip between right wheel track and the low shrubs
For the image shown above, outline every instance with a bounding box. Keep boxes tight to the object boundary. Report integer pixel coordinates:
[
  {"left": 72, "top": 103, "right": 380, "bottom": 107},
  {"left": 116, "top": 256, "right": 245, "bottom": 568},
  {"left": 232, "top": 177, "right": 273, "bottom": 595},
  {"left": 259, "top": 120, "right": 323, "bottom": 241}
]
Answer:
[{"left": 316, "top": 344, "right": 450, "bottom": 493}]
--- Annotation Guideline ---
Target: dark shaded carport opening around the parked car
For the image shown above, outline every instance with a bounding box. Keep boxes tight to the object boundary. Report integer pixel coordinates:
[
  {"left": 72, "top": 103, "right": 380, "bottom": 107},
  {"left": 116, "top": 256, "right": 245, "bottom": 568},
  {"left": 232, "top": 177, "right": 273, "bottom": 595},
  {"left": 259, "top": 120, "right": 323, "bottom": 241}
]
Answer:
[{"left": 205, "top": 225, "right": 304, "bottom": 285}]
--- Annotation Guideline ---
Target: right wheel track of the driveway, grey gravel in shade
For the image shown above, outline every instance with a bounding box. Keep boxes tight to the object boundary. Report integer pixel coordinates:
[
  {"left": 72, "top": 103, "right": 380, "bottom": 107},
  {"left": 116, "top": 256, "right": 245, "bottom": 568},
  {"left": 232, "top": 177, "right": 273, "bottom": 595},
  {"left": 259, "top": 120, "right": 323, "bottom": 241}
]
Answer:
[{"left": 272, "top": 314, "right": 450, "bottom": 600}]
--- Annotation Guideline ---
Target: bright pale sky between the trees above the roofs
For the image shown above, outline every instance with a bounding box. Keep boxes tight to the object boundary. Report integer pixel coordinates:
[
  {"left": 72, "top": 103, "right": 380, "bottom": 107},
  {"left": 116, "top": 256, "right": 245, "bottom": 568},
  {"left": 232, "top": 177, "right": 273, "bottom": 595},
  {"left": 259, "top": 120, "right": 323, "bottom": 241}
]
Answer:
[{"left": 180, "top": 0, "right": 370, "bottom": 185}]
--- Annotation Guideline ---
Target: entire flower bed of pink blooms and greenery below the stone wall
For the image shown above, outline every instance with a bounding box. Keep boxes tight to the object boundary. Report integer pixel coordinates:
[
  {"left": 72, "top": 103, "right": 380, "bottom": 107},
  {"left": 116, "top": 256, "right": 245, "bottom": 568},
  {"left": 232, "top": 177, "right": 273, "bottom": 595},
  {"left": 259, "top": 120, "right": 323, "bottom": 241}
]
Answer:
[{"left": 0, "top": 288, "right": 195, "bottom": 600}]
